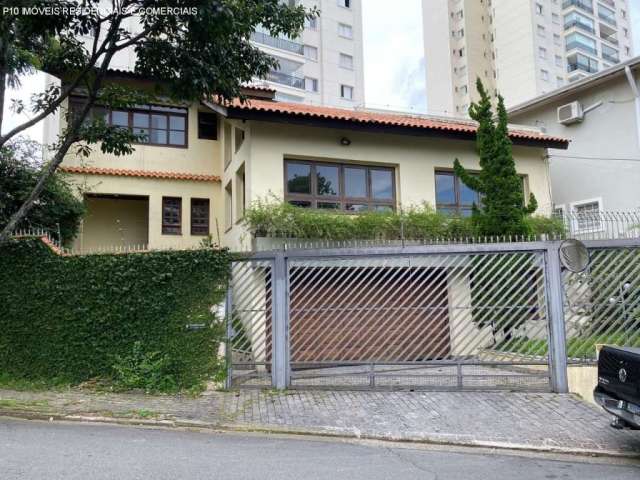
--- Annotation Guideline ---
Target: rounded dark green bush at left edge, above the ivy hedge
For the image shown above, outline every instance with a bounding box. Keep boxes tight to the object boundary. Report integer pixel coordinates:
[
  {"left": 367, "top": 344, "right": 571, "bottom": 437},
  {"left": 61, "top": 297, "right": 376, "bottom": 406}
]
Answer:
[{"left": 0, "top": 139, "right": 84, "bottom": 243}]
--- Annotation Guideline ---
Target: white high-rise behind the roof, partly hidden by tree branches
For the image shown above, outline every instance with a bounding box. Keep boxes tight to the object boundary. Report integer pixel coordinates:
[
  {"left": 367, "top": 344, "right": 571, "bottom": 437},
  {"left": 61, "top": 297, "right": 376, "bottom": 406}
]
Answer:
[{"left": 252, "top": 0, "right": 364, "bottom": 108}]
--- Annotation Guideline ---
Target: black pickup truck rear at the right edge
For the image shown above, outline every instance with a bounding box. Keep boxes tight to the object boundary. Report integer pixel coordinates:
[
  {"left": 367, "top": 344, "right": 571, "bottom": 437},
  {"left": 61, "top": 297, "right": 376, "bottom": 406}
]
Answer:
[{"left": 593, "top": 346, "right": 640, "bottom": 429}]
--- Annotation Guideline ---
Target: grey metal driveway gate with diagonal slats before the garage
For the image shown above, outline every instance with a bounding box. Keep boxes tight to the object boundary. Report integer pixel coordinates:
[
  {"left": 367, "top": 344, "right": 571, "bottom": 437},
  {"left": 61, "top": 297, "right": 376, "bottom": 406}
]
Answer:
[{"left": 227, "top": 242, "right": 566, "bottom": 390}]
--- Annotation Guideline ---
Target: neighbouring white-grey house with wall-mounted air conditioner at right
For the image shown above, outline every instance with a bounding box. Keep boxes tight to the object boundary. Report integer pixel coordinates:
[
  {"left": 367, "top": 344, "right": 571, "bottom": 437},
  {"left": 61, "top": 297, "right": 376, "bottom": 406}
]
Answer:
[{"left": 509, "top": 57, "right": 640, "bottom": 219}]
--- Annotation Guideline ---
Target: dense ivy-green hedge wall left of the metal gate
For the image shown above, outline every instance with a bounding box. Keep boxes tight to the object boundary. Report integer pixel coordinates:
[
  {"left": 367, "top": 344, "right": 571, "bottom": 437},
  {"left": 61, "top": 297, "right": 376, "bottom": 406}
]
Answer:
[{"left": 0, "top": 239, "right": 230, "bottom": 391}]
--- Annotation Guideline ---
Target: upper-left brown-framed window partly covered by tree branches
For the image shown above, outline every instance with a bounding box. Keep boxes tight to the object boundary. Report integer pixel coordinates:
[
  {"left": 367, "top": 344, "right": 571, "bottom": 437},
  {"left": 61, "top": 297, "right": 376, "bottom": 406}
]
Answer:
[{"left": 71, "top": 97, "right": 187, "bottom": 147}]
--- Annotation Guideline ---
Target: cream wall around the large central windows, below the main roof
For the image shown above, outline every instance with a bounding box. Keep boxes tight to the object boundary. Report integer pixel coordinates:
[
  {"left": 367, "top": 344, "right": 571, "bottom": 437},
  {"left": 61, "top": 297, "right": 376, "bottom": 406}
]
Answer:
[{"left": 223, "top": 122, "right": 551, "bottom": 249}]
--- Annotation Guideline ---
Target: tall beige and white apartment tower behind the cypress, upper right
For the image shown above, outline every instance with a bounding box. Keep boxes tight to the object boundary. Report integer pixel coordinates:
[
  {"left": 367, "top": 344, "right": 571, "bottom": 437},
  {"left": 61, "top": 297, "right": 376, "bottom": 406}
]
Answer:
[{"left": 422, "top": 0, "right": 633, "bottom": 115}]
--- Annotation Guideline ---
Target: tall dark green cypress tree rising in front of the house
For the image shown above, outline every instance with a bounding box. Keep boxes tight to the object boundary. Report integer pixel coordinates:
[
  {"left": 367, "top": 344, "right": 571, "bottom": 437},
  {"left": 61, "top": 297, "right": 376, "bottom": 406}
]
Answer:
[{"left": 454, "top": 79, "right": 538, "bottom": 235}]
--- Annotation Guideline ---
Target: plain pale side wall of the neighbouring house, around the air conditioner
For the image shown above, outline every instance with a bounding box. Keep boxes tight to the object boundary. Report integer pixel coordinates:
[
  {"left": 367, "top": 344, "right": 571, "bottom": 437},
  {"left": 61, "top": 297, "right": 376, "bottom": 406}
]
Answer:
[{"left": 510, "top": 73, "right": 640, "bottom": 210}]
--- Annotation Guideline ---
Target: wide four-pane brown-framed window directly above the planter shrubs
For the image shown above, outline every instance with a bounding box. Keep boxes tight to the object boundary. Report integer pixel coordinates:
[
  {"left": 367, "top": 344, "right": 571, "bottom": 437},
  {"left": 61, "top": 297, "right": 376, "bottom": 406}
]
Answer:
[{"left": 285, "top": 160, "right": 395, "bottom": 212}]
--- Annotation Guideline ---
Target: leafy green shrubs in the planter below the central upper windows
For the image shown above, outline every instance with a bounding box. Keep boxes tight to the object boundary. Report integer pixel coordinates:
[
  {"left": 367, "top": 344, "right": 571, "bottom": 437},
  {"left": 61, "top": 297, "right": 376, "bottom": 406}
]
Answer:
[{"left": 244, "top": 200, "right": 564, "bottom": 240}]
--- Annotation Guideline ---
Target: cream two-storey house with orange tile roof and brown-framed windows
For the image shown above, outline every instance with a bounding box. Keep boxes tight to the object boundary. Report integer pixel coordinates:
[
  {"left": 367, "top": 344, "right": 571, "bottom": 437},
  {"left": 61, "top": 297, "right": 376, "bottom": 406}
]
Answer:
[{"left": 55, "top": 74, "right": 566, "bottom": 250}]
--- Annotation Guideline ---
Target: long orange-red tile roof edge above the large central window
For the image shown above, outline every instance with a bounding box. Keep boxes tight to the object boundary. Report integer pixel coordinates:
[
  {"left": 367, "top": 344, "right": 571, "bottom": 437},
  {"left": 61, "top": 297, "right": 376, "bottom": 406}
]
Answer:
[{"left": 227, "top": 99, "right": 569, "bottom": 148}]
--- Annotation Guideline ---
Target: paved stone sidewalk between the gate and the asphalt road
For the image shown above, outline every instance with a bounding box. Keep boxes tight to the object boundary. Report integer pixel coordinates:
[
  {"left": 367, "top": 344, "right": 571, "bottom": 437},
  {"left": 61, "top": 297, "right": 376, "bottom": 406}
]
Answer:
[{"left": 0, "top": 390, "right": 640, "bottom": 458}]
